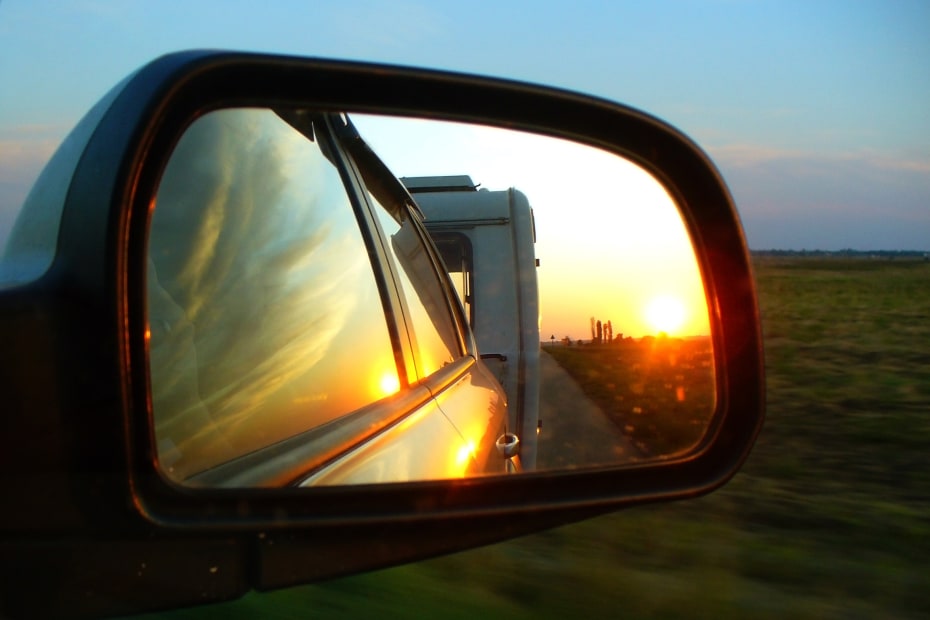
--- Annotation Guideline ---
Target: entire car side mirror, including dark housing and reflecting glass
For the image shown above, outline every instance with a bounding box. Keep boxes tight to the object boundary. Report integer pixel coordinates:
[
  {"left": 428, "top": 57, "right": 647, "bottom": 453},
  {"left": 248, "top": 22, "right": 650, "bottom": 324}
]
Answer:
[{"left": 0, "top": 52, "right": 764, "bottom": 614}]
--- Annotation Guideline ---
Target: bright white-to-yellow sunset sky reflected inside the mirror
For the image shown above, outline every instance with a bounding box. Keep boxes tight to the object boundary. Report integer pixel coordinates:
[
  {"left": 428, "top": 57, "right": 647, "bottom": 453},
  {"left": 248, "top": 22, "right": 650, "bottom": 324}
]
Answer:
[{"left": 352, "top": 115, "right": 709, "bottom": 341}]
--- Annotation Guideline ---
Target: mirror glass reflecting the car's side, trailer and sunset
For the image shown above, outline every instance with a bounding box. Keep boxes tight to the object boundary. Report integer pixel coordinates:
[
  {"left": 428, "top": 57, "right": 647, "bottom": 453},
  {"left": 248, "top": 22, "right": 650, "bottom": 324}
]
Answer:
[{"left": 146, "top": 108, "right": 716, "bottom": 487}]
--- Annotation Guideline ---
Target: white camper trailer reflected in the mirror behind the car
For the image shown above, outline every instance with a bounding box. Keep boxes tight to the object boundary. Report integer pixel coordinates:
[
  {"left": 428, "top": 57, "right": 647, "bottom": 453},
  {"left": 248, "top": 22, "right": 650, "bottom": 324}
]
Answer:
[{"left": 401, "top": 175, "right": 542, "bottom": 470}]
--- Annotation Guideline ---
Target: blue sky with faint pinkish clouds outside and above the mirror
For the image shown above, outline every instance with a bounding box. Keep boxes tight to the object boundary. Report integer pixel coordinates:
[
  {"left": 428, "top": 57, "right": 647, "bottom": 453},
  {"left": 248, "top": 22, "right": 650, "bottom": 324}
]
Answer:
[{"left": 0, "top": 0, "right": 930, "bottom": 250}]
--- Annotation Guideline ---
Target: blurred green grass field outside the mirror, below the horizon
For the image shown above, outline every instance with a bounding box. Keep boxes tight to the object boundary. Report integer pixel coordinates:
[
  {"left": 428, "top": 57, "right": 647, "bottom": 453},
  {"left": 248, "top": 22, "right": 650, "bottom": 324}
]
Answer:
[{"left": 145, "top": 258, "right": 930, "bottom": 620}]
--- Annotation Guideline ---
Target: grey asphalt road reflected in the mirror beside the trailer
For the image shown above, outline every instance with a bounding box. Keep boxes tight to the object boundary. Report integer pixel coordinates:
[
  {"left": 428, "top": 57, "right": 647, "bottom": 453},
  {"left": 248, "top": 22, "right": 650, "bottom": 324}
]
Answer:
[{"left": 536, "top": 349, "right": 639, "bottom": 469}]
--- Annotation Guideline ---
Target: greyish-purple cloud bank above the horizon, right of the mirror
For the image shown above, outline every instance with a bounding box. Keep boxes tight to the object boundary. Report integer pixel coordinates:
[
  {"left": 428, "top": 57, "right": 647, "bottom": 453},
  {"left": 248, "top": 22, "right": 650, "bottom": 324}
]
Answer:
[{"left": 708, "top": 143, "right": 930, "bottom": 249}]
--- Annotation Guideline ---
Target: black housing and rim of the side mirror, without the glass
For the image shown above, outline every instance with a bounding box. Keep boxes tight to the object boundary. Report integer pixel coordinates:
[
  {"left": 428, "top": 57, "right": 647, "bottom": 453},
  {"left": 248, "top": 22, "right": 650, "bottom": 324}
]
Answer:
[{"left": 0, "top": 51, "right": 764, "bottom": 615}]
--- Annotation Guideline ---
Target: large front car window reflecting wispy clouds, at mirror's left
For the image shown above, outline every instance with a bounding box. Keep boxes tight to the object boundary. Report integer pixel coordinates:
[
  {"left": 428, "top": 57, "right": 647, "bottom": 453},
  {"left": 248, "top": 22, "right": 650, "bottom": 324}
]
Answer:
[{"left": 147, "top": 109, "right": 399, "bottom": 480}]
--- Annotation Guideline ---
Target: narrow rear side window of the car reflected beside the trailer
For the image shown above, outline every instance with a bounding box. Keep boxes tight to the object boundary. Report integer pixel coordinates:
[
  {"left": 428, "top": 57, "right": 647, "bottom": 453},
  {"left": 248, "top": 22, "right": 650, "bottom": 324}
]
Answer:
[{"left": 368, "top": 192, "right": 464, "bottom": 379}]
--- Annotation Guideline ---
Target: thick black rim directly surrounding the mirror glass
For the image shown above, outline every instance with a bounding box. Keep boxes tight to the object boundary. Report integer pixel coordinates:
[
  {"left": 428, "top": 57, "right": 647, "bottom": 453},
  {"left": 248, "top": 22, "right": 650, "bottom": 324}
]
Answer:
[{"left": 99, "top": 52, "right": 764, "bottom": 529}]
